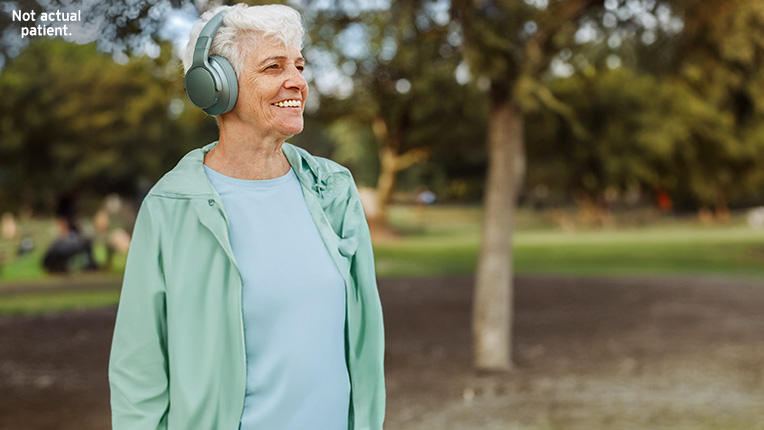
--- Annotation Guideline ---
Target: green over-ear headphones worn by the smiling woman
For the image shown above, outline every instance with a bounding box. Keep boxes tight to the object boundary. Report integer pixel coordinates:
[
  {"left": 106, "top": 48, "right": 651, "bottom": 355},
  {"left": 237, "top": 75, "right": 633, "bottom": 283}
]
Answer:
[{"left": 183, "top": 11, "right": 239, "bottom": 115}]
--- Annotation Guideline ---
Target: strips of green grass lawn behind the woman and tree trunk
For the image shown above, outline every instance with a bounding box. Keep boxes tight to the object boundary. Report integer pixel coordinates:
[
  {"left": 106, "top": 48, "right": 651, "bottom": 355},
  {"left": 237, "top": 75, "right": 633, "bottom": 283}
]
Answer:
[{"left": 0, "top": 206, "right": 764, "bottom": 315}]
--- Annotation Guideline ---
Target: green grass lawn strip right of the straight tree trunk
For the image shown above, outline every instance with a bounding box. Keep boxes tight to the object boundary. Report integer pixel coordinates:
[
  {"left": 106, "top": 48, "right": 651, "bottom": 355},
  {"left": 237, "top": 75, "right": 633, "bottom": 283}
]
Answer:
[{"left": 515, "top": 225, "right": 764, "bottom": 279}]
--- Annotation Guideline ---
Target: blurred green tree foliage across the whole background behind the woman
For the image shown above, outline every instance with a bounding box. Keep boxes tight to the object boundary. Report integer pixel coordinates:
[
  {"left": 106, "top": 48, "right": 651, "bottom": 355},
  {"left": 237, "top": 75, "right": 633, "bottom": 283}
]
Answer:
[{"left": 0, "top": 0, "right": 764, "bottom": 222}]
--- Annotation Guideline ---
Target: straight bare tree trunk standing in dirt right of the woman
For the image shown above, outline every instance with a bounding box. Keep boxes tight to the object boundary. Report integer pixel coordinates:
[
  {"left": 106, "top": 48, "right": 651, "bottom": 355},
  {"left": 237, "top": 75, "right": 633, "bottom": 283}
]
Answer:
[{"left": 472, "top": 95, "right": 525, "bottom": 371}]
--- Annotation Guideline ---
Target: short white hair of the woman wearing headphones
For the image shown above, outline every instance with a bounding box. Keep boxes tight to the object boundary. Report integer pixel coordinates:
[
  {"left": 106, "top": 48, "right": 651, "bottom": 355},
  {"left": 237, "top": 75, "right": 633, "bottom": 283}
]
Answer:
[{"left": 183, "top": 3, "right": 305, "bottom": 76}]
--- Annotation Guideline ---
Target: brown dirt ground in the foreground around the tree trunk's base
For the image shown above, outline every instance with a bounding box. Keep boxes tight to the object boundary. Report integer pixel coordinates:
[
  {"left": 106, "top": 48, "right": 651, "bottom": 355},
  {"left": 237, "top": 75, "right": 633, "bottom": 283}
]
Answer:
[{"left": 0, "top": 277, "right": 764, "bottom": 430}]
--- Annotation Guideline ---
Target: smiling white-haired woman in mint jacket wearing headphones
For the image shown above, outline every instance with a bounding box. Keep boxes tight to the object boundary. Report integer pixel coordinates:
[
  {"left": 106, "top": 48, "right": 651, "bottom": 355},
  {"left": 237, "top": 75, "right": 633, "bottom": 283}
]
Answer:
[{"left": 109, "top": 4, "right": 385, "bottom": 430}]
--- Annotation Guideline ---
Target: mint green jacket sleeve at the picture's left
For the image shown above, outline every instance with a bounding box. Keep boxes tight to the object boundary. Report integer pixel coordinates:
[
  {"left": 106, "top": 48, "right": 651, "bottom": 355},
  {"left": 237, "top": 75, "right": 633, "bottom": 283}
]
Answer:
[{"left": 109, "top": 197, "right": 169, "bottom": 430}]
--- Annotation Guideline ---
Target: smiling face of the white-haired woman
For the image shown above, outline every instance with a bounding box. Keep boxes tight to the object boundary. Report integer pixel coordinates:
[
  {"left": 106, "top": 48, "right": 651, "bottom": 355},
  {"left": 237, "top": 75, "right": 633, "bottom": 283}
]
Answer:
[{"left": 231, "top": 38, "right": 308, "bottom": 139}]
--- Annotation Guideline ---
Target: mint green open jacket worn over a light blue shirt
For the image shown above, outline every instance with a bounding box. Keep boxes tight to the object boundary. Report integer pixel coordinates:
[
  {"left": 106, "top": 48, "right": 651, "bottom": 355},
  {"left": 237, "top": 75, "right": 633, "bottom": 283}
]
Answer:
[{"left": 109, "top": 142, "right": 385, "bottom": 430}]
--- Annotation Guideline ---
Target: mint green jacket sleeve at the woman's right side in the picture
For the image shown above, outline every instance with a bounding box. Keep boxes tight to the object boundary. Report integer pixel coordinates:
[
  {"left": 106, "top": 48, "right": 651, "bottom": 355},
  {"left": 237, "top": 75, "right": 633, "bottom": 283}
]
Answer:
[{"left": 343, "top": 183, "right": 385, "bottom": 430}]
